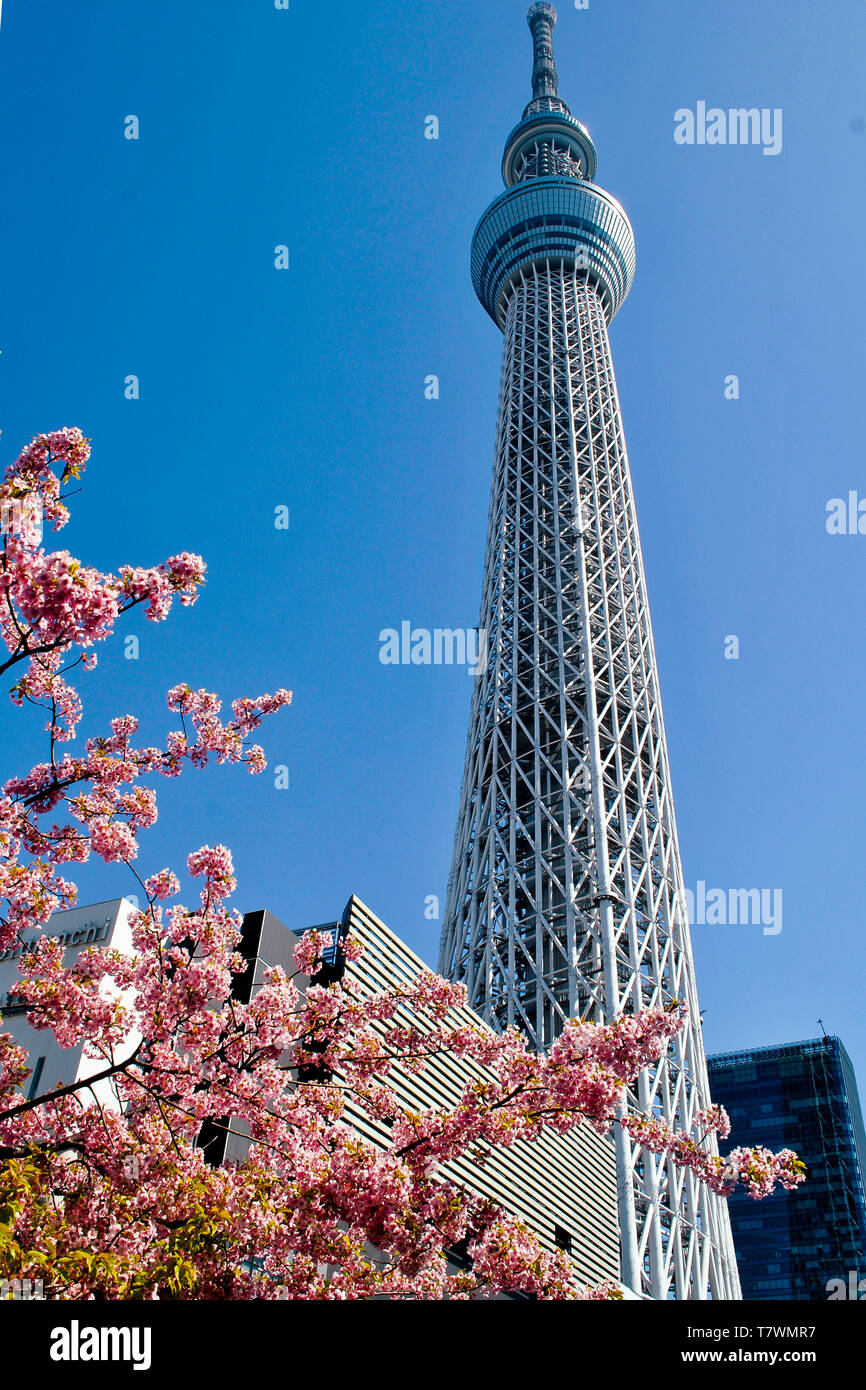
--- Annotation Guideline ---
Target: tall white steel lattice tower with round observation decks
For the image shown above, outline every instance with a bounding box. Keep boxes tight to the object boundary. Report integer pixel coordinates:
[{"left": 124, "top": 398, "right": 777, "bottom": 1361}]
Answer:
[{"left": 439, "top": 4, "right": 740, "bottom": 1298}]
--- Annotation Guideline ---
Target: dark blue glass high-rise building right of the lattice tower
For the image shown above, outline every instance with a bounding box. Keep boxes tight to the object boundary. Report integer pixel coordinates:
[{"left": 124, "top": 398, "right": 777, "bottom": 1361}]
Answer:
[{"left": 708, "top": 1037, "right": 866, "bottom": 1301}]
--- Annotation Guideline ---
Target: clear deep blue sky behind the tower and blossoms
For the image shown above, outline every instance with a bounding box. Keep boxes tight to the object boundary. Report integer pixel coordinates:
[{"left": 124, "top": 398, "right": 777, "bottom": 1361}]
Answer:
[{"left": 0, "top": 0, "right": 866, "bottom": 1086}]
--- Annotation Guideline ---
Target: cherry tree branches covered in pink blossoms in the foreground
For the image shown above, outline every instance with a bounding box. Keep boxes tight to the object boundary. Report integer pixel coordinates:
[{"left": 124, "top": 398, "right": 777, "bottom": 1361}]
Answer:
[{"left": 0, "top": 430, "right": 803, "bottom": 1300}]
